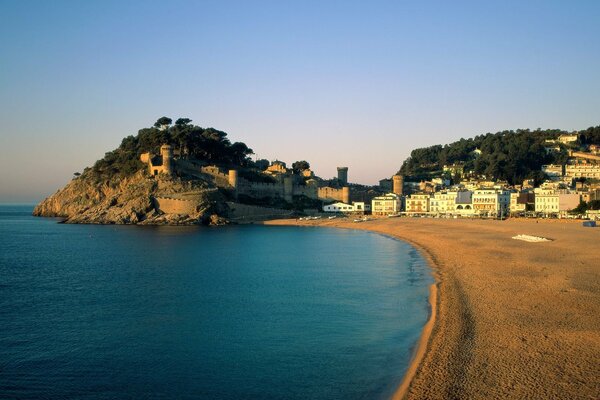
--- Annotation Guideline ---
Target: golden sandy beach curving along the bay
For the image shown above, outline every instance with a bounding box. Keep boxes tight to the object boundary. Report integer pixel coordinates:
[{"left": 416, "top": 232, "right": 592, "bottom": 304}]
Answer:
[{"left": 268, "top": 218, "right": 600, "bottom": 399}]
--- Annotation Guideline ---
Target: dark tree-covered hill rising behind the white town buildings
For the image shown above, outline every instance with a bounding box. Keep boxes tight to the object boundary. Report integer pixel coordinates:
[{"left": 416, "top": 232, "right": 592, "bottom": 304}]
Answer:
[{"left": 399, "top": 126, "right": 600, "bottom": 184}]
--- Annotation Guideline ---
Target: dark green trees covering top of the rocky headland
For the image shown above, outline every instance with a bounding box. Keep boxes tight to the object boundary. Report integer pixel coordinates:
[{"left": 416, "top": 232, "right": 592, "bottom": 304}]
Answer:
[{"left": 87, "top": 117, "right": 253, "bottom": 179}]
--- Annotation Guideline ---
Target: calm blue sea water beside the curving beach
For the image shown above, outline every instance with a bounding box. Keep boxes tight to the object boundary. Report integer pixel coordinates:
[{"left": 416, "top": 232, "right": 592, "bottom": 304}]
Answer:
[{"left": 0, "top": 206, "right": 432, "bottom": 399}]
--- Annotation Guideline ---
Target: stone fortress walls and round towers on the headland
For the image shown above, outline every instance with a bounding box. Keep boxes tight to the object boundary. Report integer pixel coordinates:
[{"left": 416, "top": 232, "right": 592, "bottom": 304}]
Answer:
[{"left": 140, "top": 144, "right": 356, "bottom": 204}]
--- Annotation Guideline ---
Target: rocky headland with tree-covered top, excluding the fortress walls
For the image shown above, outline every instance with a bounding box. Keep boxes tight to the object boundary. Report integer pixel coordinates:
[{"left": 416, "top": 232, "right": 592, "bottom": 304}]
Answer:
[{"left": 33, "top": 117, "right": 253, "bottom": 224}]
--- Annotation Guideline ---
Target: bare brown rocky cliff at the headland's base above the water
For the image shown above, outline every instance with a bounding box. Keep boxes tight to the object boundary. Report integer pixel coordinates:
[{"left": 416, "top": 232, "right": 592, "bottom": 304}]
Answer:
[{"left": 33, "top": 171, "right": 227, "bottom": 225}]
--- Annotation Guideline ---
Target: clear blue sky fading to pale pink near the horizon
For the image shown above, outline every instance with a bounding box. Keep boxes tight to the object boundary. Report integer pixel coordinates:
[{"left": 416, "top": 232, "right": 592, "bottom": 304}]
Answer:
[{"left": 0, "top": 0, "right": 600, "bottom": 203}]
